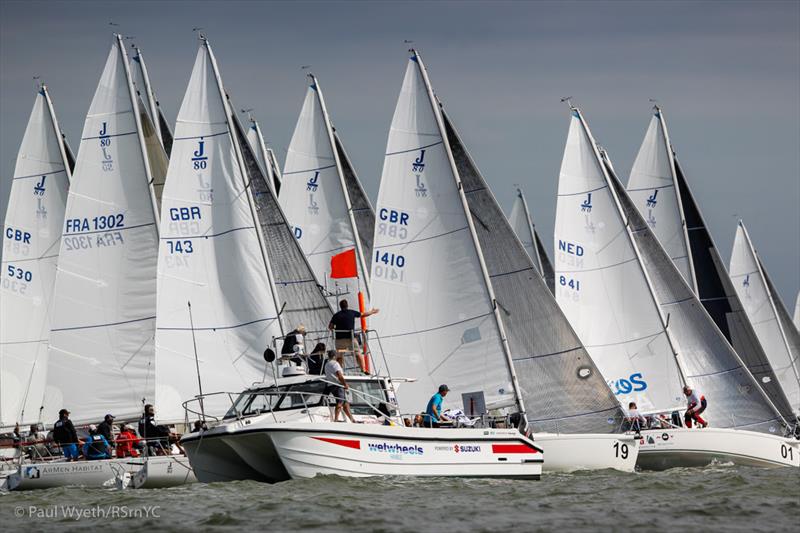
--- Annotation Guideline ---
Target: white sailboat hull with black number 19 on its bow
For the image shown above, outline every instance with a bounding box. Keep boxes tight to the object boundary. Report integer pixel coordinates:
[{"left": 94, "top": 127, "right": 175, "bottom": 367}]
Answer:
[{"left": 533, "top": 433, "right": 639, "bottom": 474}]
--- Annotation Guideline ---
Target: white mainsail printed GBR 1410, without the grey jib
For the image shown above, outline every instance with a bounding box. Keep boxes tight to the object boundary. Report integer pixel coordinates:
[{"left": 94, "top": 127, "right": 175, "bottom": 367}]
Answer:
[{"left": 372, "top": 55, "right": 515, "bottom": 411}]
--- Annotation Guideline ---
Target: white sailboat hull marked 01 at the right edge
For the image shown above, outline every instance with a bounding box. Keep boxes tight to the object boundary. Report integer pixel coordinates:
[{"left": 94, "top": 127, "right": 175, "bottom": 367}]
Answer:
[{"left": 637, "top": 428, "right": 800, "bottom": 470}]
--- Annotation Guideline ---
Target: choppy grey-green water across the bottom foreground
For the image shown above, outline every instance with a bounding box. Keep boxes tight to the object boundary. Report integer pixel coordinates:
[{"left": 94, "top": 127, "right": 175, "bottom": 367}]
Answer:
[{"left": 0, "top": 466, "right": 800, "bottom": 533}]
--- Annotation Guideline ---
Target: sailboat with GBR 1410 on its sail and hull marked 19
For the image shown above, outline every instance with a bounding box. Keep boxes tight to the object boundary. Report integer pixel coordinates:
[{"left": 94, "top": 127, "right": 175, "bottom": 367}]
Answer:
[{"left": 372, "top": 52, "right": 638, "bottom": 471}]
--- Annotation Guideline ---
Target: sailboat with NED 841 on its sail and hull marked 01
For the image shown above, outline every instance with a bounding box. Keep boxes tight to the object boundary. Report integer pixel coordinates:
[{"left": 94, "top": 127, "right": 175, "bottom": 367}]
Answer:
[{"left": 555, "top": 106, "right": 800, "bottom": 469}]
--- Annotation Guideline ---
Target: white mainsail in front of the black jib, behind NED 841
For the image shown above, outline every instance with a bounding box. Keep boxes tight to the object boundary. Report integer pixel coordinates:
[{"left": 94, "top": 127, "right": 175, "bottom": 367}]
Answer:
[{"left": 627, "top": 108, "right": 695, "bottom": 289}]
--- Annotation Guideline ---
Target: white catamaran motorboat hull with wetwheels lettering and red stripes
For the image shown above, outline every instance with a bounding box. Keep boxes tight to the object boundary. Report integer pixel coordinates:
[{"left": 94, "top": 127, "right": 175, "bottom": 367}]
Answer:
[{"left": 183, "top": 421, "right": 543, "bottom": 482}]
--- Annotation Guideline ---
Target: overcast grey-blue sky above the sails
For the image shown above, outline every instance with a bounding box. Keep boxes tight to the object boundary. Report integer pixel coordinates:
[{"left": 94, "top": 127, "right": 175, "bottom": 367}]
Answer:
[{"left": 0, "top": 0, "right": 800, "bottom": 308}]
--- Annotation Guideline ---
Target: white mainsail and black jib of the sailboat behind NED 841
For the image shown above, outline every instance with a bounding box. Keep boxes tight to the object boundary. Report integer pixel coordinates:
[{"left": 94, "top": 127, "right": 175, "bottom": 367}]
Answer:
[{"left": 627, "top": 106, "right": 794, "bottom": 420}]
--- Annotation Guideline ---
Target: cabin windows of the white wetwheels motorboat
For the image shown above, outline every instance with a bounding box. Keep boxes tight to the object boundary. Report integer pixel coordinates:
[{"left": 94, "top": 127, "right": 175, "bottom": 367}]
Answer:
[{"left": 225, "top": 380, "right": 388, "bottom": 418}]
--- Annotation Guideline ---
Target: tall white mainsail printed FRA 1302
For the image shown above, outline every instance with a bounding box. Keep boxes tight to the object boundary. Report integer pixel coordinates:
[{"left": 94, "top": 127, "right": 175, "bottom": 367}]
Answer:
[{"left": 45, "top": 38, "right": 158, "bottom": 422}]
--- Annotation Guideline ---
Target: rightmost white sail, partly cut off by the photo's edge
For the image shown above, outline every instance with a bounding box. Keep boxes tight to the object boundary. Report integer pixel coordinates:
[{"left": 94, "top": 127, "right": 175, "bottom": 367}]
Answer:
[{"left": 730, "top": 221, "right": 800, "bottom": 416}]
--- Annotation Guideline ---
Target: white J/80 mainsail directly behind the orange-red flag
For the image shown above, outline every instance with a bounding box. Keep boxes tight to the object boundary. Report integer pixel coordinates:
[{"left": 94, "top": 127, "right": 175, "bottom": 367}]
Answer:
[{"left": 280, "top": 75, "right": 370, "bottom": 301}]
